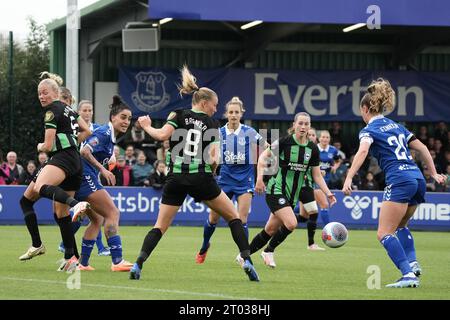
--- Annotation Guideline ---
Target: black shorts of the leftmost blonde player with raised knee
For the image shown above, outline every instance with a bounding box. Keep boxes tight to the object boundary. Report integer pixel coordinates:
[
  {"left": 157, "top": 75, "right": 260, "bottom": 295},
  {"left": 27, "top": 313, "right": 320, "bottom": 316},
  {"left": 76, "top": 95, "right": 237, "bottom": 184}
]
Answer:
[{"left": 33, "top": 148, "right": 83, "bottom": 191}]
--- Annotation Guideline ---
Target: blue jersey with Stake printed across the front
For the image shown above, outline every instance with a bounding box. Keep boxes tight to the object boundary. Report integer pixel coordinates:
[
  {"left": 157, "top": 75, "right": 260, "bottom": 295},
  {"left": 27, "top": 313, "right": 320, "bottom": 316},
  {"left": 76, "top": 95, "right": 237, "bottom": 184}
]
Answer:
[{"left": 218, "top": 124, "right": 262, "bottom": 185}]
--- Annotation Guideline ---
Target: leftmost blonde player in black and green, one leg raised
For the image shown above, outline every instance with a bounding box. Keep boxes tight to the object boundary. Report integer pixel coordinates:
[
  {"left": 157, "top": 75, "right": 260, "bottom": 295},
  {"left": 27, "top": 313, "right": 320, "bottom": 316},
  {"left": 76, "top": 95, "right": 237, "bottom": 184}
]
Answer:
[{"left": 19, "top": 73, "right": 91, "bottom": 270}]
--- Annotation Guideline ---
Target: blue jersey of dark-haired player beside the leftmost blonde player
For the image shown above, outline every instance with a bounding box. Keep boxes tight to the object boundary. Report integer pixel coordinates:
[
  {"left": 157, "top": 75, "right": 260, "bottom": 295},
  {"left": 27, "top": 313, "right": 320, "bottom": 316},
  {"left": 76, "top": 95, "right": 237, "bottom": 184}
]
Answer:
[{"left": 82, "top": 123, "right": 116, "bottom": 175}]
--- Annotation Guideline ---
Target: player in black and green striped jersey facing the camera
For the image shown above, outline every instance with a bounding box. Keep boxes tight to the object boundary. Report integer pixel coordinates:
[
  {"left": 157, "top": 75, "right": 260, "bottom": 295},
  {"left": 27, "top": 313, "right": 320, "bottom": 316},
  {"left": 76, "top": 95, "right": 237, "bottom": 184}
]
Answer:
[{"left": 241, "top": 112, "right": 336, "bottom": 267}]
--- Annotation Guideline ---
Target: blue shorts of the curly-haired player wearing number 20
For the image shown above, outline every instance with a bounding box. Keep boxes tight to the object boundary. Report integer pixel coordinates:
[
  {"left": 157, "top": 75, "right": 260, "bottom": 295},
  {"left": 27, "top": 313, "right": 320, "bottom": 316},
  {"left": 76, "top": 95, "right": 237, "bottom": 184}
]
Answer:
[{"left": 383, "top": 179, "right": 427, "bottom": 206}]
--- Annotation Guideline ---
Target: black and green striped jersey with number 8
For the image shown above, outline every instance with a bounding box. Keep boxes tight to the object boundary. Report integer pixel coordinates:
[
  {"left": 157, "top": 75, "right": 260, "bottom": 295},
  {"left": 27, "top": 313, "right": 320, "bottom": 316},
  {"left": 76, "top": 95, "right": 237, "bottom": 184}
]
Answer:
[{"left": 166, "top": 109, "right": 220, "bottom": 174}]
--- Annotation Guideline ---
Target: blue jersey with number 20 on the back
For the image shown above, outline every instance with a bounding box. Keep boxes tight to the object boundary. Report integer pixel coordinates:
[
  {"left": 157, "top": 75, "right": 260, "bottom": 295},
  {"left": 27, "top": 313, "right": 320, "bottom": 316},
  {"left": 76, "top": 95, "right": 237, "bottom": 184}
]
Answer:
[{"left": 359, "top": 115, "right": 423, "bottom": 185}]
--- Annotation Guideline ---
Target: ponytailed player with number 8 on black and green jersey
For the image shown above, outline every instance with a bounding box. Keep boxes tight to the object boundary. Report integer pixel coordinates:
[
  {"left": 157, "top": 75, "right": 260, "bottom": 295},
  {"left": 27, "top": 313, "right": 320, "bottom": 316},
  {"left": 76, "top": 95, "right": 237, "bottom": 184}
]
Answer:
[{"left": 130, "top": 66, "right": 259, "bottom": 281}]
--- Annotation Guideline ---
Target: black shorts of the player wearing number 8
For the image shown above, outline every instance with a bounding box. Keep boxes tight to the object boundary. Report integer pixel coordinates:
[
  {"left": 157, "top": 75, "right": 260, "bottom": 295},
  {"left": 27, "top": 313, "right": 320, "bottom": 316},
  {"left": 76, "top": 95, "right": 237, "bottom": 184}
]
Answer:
[{"left": 161, "top": 173, "right": 222, "bottom": 206}]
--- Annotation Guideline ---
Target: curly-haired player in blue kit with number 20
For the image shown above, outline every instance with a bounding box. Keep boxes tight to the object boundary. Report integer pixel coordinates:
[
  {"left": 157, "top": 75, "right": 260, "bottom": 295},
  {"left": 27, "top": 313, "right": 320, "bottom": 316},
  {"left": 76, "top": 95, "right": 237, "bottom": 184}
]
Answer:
[{"left": 342, "top": 78, "right": 446, "bottom": 288}]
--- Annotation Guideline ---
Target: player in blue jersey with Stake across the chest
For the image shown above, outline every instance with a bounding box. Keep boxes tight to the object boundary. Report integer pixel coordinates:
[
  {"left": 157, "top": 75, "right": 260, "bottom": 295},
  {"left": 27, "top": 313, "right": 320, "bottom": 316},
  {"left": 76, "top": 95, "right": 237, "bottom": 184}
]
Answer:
[{"left": 195, "top": 97, "right": 262, "bottom": 264}]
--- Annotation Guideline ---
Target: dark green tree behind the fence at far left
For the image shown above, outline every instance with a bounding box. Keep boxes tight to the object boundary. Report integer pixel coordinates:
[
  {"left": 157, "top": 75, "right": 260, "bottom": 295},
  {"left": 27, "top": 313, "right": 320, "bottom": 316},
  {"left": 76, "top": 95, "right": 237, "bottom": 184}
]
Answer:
[{"left": 0, "top": 17, "right": 49, "bottom": 163}]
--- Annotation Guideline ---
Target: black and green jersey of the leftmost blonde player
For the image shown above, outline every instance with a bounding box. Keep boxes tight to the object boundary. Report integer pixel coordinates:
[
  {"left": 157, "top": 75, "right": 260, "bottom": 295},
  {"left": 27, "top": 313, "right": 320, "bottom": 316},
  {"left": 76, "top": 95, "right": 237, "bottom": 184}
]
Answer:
[{"left": 44, "top": 101, "right": 79, "bottom": 154}]
